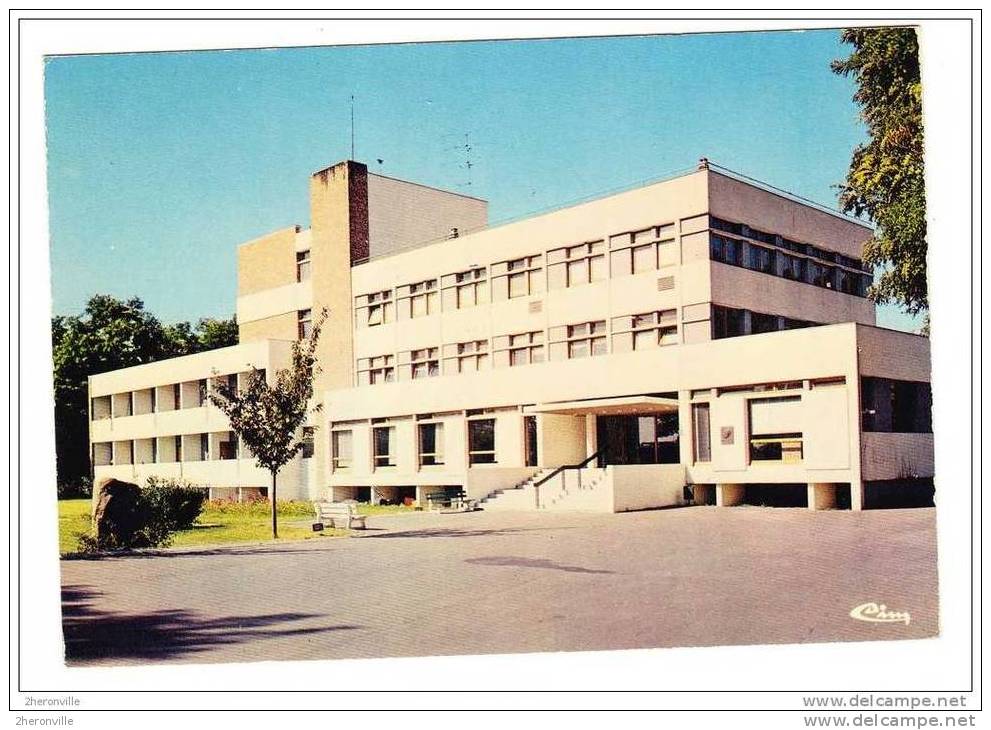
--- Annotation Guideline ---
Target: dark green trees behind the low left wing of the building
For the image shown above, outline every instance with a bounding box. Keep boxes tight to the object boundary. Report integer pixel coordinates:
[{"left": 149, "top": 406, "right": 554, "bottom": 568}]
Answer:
[{"left": 52, "top": 294, "right": 237, "bottom": 487}]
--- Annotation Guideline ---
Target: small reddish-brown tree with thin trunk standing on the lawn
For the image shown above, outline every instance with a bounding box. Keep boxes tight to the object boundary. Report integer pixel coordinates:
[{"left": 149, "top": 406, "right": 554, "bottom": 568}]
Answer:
[{"left": 209, "top": 309, "right": 327, "bottom": 539}]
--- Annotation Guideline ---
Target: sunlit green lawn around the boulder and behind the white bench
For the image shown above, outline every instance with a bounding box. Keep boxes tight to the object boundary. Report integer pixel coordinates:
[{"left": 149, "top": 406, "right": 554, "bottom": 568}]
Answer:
[{"left": 58, "top": 499, "right": 348, "bottom": 555}]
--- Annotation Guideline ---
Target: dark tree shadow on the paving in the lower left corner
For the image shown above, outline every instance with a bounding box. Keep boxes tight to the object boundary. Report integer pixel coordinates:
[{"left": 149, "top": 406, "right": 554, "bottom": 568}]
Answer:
[{"left": 62, "top": 585, "right": 363, "bottom": 664}]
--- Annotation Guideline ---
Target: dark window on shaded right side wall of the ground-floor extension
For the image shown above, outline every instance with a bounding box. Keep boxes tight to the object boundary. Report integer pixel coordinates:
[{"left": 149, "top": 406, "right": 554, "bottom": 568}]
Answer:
[{"left": 860, "top": 377, "right": 932, "bottom": 433}]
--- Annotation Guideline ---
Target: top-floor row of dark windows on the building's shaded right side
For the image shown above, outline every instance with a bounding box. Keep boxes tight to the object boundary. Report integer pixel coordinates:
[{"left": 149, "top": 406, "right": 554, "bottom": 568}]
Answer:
[{"left": 709, "top": 233, "right": 873, "bottom": 297}]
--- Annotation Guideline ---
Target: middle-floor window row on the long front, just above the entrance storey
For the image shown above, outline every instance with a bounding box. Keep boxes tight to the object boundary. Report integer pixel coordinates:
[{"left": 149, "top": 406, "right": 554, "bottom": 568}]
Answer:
[{"left": 355, "top": 309, "right": 678, "bottom": 385}]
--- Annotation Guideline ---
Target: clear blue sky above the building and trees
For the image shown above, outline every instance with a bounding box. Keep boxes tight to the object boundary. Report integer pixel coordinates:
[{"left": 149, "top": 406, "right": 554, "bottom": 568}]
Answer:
[{"left": 45, "top": 31, "right": 913, "bottom": 328}]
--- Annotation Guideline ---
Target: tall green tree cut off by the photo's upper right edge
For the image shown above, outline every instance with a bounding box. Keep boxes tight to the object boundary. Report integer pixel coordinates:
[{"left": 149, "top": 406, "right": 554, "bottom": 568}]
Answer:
[{"left": 832, "top": 28, "right": 929, "bottom": 314}]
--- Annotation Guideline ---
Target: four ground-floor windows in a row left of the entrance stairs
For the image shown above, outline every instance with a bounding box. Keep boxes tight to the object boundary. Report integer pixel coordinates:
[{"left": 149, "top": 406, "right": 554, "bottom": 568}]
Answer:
[{"left": 330, "top": 418, "right": 496, "bottom": 471}]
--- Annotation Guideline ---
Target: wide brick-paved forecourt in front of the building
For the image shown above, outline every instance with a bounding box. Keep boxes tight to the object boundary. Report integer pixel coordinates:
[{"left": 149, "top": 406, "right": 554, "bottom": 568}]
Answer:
[{"left": 62, "top": 507, "right": 937, "bottom": 664}]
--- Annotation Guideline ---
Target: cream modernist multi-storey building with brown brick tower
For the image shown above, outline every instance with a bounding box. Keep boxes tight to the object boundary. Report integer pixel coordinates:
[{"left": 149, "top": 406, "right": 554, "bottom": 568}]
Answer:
[{"left": 90, "top": 161, "right": 933, "bottom": 511}]
